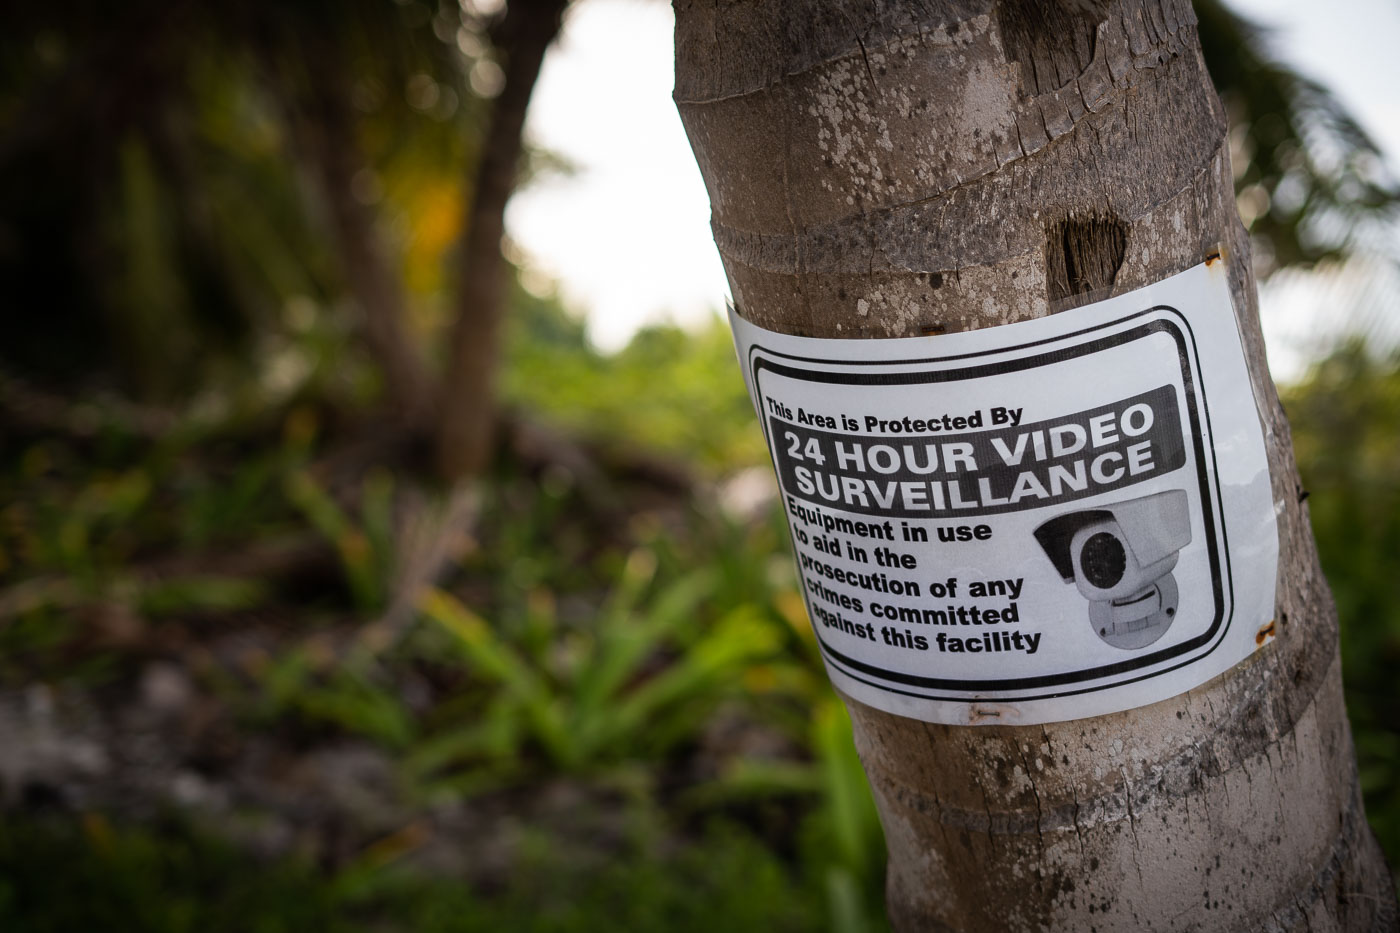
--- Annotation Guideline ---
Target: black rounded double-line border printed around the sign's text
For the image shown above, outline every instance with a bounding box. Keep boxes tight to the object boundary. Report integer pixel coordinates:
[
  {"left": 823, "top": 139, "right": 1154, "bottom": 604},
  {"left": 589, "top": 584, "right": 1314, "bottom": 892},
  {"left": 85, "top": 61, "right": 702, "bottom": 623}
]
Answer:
[{"left": 748, "top": 304, "right": 1235, "bottom": 703}]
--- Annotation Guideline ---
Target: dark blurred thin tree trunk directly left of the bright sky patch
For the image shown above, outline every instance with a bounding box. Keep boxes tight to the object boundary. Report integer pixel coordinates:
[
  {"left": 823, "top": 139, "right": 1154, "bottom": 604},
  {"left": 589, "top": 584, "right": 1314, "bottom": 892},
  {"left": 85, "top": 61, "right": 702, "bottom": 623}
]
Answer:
[{"left": 437, "top": 0, "right": 568, "bottom": 479}]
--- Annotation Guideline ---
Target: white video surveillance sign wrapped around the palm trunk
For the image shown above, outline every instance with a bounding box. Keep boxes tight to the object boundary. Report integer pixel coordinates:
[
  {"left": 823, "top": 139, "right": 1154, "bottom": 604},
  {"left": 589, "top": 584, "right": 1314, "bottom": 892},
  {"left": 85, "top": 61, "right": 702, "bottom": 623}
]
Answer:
[{"left": 731, "top": 261, "right": 1278, "bottom": 724}]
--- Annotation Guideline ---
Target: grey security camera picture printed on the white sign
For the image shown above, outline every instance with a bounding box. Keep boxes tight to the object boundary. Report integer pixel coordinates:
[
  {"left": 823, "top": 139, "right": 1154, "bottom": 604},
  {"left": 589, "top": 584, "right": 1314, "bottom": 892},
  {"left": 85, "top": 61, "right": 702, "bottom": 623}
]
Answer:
[{"left": 1035, "top": 489, "right": 1191, "bottom": 650}]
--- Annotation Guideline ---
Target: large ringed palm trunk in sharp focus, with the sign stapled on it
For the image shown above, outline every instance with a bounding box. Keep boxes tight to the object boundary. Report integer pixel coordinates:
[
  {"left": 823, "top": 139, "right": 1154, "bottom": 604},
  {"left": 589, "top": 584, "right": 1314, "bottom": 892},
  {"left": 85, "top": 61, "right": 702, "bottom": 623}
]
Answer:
[{"left": 676, "top": 0, "right": 1396, "bottom": 933}]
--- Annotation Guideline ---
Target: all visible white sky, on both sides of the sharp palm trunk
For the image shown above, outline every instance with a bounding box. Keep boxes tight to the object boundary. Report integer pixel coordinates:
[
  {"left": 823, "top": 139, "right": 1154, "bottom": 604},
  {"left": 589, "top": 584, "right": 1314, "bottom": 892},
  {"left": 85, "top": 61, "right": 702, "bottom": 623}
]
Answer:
[{"left": 507, "top": 0, "right": 1400, "bottom": 378}]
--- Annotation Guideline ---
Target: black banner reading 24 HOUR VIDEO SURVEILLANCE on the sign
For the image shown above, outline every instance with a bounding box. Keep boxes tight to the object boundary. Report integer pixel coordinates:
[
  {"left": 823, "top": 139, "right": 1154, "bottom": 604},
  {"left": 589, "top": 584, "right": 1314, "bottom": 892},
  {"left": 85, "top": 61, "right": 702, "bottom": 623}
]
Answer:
[{"left": 769, "top": 385, "right": 1186, "bottom": 518}]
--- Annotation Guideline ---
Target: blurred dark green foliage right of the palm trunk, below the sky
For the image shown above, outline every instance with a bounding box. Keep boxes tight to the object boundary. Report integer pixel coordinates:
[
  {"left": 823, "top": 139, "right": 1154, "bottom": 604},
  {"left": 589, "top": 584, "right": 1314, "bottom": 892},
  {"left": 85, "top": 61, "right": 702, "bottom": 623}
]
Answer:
[{"left": 1284, "top": 345, "right": 1400, "bottom": 863}]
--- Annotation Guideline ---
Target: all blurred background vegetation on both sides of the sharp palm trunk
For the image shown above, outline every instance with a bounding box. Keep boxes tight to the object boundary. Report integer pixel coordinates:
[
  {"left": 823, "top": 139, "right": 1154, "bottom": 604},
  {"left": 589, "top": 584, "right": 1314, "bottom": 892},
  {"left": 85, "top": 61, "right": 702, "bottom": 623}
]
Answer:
[{"left": 0, "top": 0, "right": 1400, "bottom": 933}]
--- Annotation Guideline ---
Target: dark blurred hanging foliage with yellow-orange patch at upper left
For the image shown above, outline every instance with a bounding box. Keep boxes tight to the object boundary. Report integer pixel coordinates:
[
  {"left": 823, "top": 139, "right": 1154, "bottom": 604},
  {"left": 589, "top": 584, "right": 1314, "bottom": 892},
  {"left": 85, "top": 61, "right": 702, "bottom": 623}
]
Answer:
[{"left": 0, "top": 0, "right": 498, "bottom": 403}]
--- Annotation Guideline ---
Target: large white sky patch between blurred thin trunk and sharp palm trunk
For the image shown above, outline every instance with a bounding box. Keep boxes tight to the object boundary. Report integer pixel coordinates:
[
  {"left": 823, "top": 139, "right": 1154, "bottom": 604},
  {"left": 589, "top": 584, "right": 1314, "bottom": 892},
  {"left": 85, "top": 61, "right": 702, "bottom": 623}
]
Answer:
[{"left": 505, "top": 0, "right": 727, "bottom": 349}]
